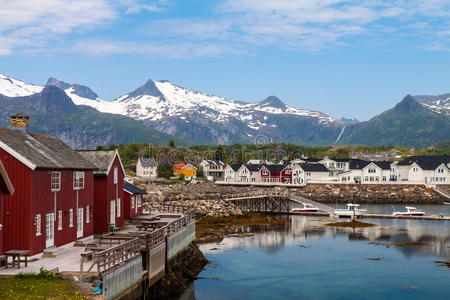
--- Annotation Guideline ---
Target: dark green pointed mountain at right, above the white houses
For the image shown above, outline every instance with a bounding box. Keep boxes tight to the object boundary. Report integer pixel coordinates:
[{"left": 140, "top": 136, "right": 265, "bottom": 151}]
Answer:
[{"left": 339, "top": 95, "right": 450, "bottom": 147}]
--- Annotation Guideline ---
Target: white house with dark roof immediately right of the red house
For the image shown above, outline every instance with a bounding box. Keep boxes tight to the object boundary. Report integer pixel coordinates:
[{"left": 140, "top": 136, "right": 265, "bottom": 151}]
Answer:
[{"left": 292, "top": 163, "right": 331, "bottom": 184}]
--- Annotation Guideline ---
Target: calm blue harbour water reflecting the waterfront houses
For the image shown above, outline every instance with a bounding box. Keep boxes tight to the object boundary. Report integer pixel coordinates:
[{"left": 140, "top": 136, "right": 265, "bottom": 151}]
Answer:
[{"left": 187, "top": 207, "right": 450, "bottom": 300}]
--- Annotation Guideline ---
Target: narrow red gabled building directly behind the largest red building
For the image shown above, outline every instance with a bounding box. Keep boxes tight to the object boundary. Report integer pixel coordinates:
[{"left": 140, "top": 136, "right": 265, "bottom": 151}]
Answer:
[{"left": 78, "top": 150, "right": 125, "bottom": 233}]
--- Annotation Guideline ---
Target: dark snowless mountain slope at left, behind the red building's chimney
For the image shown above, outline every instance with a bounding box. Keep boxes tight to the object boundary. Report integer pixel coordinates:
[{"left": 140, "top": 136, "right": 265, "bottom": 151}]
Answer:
[{"left": 0, "top": 86, "right": 186, "bottom": 149}]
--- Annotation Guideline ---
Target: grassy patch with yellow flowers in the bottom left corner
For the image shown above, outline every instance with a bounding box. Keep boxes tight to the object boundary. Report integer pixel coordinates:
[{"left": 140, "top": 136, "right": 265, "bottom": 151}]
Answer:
[{"left": 0, "top": 270, "right": 87, "bottom": 300}]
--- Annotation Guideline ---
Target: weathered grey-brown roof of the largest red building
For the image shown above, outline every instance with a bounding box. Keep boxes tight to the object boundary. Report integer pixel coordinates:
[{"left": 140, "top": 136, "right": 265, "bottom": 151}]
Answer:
[{"left": 0, "top": 128, "right": 97, "bottom": 170}]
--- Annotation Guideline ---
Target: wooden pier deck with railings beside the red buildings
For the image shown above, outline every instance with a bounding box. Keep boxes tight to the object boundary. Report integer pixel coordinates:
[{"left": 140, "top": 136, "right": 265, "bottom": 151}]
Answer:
[{"left": 0, "top": 205, "right": 195, "bottom": 299}]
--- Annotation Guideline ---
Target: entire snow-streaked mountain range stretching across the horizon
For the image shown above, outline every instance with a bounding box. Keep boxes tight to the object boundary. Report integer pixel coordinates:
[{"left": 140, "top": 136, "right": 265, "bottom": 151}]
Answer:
[{"left": 0, "top": 74, "right": 450, "bottom": 148}]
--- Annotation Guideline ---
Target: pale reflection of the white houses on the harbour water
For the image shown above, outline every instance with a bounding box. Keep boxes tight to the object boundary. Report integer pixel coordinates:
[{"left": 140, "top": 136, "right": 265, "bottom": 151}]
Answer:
[{"left": 200, "top": 216, "right": 450, "bottom": 258}]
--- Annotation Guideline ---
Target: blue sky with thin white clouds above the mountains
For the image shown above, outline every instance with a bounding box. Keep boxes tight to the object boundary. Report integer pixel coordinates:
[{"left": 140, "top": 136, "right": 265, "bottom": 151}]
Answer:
[{"left": 0, "top": 0, "right": 450, "bottom": 120}]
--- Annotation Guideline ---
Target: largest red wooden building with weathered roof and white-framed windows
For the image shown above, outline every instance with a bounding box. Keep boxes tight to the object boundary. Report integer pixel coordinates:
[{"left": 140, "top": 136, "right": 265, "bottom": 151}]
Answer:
[{"left": 0, "top": 128, "right": 96, "bottom": 255}]
